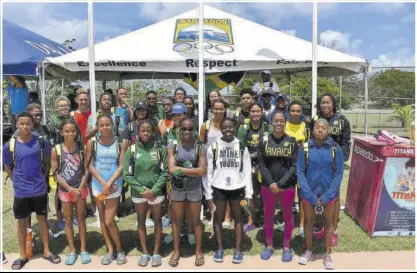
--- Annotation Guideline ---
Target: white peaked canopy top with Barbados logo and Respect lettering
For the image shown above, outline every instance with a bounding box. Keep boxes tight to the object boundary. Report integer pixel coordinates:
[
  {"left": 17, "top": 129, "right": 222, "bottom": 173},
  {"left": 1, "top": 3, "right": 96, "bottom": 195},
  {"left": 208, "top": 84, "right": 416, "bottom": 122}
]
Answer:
[{"left": 45, "top": 5, "right": 368, "bottom": 131}]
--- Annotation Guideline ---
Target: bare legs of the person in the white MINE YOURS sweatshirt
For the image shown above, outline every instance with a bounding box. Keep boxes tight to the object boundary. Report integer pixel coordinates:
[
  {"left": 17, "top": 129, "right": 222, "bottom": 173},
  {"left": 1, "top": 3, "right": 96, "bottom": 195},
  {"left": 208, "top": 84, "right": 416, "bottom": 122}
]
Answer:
[{"left": 213, "top": 200, "right": 243, "bottom": 251}]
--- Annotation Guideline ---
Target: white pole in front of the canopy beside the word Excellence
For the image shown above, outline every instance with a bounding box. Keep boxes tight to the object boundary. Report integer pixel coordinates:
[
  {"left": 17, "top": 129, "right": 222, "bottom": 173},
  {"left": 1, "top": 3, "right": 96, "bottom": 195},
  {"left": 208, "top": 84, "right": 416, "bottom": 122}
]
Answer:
[{"left": 88, "top": 0, "right": 97, "bottom": 120}]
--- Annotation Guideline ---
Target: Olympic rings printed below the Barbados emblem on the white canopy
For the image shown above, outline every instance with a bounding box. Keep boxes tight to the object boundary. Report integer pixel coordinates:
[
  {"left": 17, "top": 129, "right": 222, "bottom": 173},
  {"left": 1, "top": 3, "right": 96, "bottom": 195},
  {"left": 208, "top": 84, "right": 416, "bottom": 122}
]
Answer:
[{"left": 172, "top": 41, "right": 235, "bottom": 55}]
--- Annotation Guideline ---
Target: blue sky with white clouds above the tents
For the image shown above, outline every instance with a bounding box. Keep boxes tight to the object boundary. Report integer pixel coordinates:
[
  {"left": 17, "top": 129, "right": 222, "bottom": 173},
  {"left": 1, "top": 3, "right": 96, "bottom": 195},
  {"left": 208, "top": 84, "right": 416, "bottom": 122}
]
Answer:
[{"left": 3, "top": 2, "right": 415, "bottom": 66}]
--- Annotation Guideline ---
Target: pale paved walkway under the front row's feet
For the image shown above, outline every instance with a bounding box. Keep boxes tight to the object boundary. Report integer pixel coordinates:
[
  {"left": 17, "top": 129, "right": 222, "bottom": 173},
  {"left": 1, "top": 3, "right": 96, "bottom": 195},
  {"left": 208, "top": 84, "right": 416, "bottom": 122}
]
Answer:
[{"left": 3, "top": 251, "right": 415, "bottom": 271}]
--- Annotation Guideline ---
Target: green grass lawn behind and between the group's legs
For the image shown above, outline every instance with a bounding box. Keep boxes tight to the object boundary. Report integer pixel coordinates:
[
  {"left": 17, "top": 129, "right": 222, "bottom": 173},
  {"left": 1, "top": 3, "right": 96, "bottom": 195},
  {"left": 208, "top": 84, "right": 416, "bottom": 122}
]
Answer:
[{"left": 3, "top": 163, "right": 414, "bottom": 257}]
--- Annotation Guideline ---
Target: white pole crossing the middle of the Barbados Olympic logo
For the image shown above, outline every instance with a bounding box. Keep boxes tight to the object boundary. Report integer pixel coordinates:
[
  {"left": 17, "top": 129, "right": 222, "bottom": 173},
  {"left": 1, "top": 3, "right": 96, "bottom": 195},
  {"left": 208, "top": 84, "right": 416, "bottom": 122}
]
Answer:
[{"left": 198, "top": 1, "right": 205, "bottom": 125}]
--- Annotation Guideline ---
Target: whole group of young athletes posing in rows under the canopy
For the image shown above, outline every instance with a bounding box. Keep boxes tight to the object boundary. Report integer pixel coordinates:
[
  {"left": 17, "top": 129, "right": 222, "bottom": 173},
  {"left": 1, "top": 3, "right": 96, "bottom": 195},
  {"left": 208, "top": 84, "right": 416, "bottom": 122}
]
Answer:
[{"left": 3, "top": 83, "right": 350, "bottom": 269}]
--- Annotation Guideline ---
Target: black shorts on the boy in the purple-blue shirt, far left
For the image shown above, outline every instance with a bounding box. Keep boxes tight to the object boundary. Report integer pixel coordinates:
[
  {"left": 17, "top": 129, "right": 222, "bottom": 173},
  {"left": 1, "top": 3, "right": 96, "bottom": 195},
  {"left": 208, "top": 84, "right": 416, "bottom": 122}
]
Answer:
[{"left": 13, "top": 194, "right": 48, "bottom": 220}]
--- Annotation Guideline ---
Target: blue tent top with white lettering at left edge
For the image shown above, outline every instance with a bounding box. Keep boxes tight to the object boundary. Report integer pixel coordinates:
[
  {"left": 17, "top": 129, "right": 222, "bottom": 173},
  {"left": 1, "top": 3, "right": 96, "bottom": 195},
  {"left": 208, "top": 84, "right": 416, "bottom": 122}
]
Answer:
[{"left": 2, "top": 20, "right": 70, "bottom": 76}]
